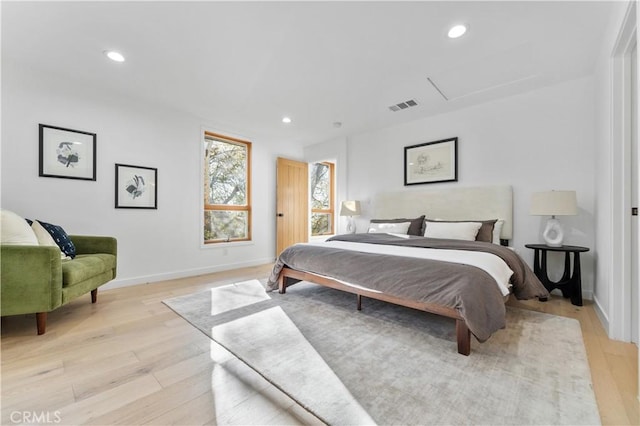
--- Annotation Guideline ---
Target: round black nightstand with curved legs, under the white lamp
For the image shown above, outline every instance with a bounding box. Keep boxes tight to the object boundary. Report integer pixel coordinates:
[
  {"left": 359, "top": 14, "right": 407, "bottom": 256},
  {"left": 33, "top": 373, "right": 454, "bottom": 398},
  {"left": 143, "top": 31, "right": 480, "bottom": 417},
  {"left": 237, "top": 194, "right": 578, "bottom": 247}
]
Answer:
[{"left": 524, "top": 244, "right": 589, "bottom": 306}]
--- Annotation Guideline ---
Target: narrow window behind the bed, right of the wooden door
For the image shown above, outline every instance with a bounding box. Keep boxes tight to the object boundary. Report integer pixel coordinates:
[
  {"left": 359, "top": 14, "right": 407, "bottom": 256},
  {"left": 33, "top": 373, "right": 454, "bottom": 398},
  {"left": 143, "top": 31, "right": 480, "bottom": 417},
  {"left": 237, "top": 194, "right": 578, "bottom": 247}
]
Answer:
[{"left": 309, "top": 163, "right": 335, "bottom": 235}]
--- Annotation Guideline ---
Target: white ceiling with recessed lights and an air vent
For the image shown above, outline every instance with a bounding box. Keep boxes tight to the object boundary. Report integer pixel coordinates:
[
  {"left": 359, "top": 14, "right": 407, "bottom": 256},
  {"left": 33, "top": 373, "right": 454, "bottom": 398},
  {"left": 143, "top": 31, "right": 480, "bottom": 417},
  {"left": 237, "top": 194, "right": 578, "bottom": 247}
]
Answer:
[{"left": 2, "top": 1, "right": 612, "bottom": 145}]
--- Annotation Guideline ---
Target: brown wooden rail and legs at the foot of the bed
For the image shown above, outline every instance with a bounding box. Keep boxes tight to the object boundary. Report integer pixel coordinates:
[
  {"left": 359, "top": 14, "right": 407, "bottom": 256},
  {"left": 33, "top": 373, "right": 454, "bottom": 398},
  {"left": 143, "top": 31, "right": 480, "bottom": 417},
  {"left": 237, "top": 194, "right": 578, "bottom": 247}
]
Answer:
[{"left": 278, "top": 267, "right": 471, "bottom": 356}]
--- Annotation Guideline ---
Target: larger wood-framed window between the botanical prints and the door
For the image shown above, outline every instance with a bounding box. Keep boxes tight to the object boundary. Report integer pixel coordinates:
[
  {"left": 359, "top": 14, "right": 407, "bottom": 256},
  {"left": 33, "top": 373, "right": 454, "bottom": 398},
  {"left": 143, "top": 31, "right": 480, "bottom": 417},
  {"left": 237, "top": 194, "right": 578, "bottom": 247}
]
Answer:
[{"left": 203, "top": 132, "right": 251, "bottom": 244}]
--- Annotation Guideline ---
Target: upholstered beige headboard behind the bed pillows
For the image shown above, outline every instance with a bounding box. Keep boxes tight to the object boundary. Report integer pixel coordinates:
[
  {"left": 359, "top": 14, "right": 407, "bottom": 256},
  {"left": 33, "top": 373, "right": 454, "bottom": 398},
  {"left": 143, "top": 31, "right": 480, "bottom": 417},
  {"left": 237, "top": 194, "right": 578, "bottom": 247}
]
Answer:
[{"left": 372, "top": 185, "right": 513, "bottom": 240}]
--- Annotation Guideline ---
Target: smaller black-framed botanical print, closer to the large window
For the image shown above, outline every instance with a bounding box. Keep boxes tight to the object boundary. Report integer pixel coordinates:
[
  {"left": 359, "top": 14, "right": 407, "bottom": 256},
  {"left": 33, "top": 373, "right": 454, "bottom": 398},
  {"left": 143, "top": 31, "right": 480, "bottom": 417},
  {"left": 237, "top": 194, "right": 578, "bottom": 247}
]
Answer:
[{"left": 116, "top": 164, "right": 158, "bottom": 209}]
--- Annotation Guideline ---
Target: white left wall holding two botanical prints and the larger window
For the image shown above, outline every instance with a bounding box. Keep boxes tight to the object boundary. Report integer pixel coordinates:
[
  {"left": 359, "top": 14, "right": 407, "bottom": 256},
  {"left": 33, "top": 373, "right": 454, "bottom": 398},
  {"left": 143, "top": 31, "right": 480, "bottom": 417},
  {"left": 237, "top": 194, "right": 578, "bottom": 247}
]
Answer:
[{"left": 1, "top": 62, "right": 302, "bottom": 287}]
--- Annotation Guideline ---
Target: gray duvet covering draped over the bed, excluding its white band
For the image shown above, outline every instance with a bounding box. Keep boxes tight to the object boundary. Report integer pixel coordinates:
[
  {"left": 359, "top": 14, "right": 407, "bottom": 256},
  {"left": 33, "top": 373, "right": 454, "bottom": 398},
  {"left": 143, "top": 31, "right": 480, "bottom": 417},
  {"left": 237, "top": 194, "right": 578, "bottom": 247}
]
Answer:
[{"left": 267, "top": 234, "right": 549, "bottom": 342}]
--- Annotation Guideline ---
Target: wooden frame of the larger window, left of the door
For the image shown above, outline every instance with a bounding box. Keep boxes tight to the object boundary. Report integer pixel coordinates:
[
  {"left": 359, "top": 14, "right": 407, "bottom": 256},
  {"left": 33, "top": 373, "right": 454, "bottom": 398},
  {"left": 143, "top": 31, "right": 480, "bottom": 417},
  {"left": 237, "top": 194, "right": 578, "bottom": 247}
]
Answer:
[{"left": 206, "top": 130, "right": 252, "bottom": 247}]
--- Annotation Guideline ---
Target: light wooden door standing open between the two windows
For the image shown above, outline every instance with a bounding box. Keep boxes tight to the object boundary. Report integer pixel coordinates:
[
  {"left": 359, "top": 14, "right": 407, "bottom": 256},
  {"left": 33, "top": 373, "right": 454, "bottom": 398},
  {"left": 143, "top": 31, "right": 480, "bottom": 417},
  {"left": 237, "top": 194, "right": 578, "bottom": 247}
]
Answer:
[{"left": 276, "top": 158, "right": 309, "bottom": 255}]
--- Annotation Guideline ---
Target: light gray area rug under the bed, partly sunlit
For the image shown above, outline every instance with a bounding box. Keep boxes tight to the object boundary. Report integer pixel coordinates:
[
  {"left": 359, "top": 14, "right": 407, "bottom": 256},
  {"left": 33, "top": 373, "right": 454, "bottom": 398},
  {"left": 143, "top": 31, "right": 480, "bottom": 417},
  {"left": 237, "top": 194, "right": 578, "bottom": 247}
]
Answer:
[{"left": 164, "top": 280, "right": 600, "bottom": 425}]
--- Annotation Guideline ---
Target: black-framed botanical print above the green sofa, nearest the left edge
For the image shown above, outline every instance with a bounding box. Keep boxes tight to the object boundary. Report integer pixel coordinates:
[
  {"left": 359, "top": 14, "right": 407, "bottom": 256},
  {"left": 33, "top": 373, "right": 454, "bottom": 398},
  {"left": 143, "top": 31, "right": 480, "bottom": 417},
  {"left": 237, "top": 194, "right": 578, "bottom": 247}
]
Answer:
[{"left": 39, "top": 124, "right": 96, "bottom": 180}]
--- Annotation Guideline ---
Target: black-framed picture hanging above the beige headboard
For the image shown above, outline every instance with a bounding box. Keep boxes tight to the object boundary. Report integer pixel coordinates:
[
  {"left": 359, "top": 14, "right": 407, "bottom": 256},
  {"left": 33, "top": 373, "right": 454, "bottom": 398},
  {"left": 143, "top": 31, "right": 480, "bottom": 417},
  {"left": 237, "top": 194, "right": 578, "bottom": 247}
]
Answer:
[{"left": 404, "top": 137, "right": 458, "bottom": 186}]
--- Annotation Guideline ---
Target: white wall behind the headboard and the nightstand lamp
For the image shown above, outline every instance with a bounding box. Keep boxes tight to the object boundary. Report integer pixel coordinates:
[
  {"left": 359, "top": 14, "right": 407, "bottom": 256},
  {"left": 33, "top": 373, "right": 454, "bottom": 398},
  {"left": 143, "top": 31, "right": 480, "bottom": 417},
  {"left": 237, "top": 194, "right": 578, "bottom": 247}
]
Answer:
[{"left": 348, "top": 78, "right": 595, "bottom": 298}]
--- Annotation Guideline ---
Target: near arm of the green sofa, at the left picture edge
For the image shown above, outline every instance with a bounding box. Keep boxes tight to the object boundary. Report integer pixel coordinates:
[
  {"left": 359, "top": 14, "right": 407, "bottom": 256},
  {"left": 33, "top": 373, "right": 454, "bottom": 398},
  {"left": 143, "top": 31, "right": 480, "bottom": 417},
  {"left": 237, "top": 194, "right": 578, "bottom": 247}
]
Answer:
[{"left": 0, "top": 245, "right": 62, "bottom": 316}]
